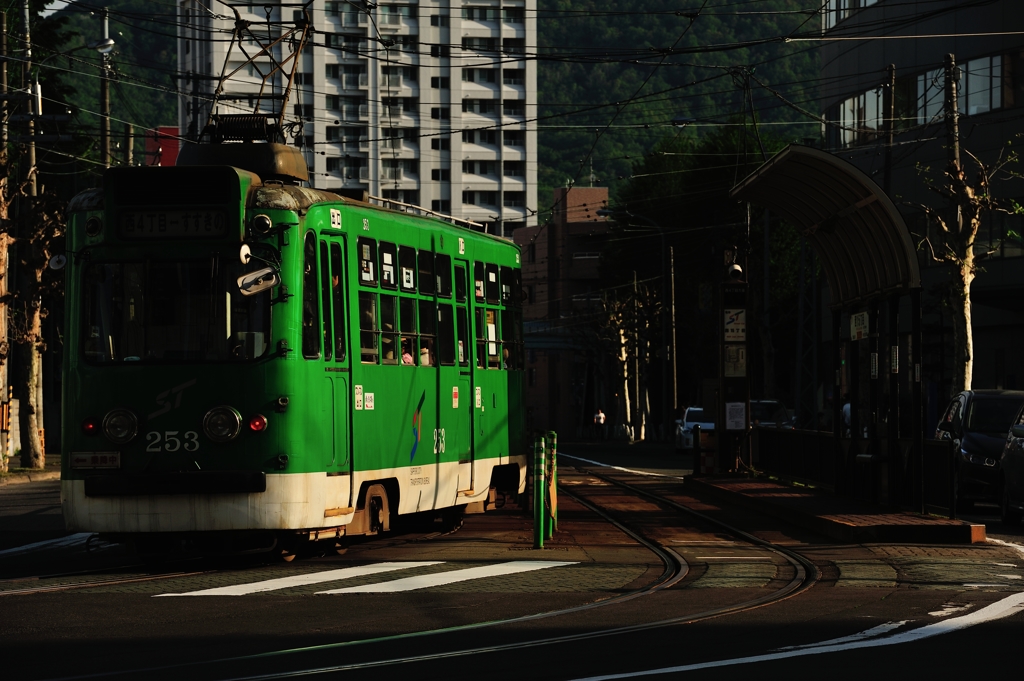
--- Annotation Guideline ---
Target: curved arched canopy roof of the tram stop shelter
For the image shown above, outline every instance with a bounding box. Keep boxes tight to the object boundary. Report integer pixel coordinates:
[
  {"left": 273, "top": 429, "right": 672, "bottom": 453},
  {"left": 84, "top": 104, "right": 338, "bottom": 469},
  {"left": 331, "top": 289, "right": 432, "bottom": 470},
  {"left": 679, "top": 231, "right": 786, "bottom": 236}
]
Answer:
[{"left": 730, "top": 144, "right": 921, "bottom": 307}]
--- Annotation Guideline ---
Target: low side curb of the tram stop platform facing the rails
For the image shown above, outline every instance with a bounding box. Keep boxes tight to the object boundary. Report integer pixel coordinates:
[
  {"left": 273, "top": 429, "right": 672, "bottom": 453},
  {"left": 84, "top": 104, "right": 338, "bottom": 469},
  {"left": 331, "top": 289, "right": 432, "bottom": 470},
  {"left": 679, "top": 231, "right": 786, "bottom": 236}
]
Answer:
[{"left": 686, "top": 477, "right": 986, "bottom": 544}]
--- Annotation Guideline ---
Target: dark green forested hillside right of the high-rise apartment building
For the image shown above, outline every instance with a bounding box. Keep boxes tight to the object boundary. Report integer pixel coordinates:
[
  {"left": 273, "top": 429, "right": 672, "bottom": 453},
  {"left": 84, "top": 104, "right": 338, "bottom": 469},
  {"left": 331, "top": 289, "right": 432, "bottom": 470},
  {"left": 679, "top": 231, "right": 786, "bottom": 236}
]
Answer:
[{"left": 538, "top": 0, "right": 821, "bottom": 209}]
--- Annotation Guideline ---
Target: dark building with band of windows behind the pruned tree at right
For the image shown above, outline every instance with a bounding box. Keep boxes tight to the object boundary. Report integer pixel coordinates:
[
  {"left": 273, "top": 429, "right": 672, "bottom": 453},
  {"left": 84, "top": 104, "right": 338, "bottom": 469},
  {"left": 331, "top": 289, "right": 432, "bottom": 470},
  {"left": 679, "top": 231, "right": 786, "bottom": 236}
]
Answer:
[{"left": 820, "top": 0, "right": 1024, "bottom": 427}]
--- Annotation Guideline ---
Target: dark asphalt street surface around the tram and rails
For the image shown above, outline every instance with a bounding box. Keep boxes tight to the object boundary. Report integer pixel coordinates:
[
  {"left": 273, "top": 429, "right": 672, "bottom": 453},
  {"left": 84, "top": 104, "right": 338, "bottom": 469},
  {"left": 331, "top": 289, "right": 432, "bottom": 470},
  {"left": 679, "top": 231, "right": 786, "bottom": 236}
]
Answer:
[{"left": 0, "top": 444, "right": 1024, "bottom": 680}]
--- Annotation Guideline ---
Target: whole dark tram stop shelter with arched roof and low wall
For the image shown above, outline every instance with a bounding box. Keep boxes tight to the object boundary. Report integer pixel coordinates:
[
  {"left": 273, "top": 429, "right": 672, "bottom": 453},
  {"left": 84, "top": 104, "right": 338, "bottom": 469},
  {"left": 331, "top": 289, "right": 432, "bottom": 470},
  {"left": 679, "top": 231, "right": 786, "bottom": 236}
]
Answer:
[{"left": 730, "top": 144, "right": 933, "bottom": 509}]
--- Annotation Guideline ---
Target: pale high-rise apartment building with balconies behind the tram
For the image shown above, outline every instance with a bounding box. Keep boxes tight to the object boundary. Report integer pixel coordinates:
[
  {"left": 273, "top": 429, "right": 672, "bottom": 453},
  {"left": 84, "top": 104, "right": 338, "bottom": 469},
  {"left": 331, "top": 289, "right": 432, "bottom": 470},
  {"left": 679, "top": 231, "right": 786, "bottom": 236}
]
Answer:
[{"left": 178, "top": 0, "right": 538, "bottom": 235}]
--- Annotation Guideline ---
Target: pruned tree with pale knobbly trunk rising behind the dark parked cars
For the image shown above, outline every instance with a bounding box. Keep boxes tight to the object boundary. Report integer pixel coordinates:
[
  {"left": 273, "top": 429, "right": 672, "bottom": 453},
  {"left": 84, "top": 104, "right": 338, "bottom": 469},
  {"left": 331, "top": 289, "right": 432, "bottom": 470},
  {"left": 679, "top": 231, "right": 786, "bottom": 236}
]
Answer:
[{"left": 908, "top": 150, "right": 1024, "bottom": 394}]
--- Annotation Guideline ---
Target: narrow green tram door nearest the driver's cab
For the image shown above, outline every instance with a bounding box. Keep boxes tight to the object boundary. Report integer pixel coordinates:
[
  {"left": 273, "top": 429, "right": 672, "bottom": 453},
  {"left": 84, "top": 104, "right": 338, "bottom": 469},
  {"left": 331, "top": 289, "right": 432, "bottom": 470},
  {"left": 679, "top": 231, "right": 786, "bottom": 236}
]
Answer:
[{"left": 321, "top": 237, "right": 351, "bottom": 486}]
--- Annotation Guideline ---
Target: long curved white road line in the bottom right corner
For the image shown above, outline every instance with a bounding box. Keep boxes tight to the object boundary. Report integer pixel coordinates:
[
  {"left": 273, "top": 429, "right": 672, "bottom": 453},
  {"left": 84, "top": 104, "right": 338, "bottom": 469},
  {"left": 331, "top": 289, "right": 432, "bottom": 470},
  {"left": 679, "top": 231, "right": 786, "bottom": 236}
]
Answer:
[{"left": 574, "top": 593, "right": 1024, "bottom": 681}]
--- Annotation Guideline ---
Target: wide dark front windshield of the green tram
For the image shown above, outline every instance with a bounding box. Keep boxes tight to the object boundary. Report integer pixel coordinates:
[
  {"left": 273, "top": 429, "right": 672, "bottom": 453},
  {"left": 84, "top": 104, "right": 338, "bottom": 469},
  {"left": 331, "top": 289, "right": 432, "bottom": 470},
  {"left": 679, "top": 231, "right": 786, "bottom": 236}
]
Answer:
[{"left": 81, "top": 256, "right": 270, "bottom": 364}]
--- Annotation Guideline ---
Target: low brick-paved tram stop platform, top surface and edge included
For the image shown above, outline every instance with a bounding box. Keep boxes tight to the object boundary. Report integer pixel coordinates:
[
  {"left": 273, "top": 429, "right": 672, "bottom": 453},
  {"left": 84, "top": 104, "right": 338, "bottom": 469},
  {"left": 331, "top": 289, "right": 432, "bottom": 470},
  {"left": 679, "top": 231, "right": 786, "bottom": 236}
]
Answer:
[{"left": 686, "top": 476, "right": 985, "bottom": 544}]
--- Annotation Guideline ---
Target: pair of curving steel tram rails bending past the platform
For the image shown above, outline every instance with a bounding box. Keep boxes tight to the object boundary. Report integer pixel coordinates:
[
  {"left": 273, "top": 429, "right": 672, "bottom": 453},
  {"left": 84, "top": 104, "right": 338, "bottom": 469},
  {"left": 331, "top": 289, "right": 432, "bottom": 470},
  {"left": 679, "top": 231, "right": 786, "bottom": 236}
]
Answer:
[{"left": 49, "top": 456, "right": 819, "bottom": 681}]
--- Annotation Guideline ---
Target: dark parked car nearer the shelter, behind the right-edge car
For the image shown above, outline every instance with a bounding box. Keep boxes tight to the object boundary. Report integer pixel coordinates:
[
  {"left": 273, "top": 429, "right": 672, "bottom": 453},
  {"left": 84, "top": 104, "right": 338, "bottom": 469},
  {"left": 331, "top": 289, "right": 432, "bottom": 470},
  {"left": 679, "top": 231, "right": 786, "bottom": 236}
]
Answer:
[{"left": 935, "top": 390, "right": 1024, "bottom": 507}]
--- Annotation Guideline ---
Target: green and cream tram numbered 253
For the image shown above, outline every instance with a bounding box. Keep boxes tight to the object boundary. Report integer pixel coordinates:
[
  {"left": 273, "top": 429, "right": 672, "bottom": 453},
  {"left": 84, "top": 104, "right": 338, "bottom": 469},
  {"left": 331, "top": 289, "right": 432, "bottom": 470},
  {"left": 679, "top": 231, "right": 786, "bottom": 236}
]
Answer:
[{"left": 56, "top": 143, "right": 526, "bottom": 549}]
